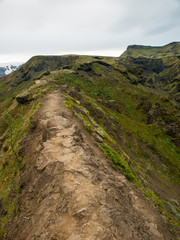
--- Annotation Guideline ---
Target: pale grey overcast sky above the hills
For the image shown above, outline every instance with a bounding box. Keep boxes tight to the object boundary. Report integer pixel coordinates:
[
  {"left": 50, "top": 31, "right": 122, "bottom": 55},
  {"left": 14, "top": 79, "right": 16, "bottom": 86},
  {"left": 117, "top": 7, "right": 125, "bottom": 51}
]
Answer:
[{"left": 0, "top": 0, "right": 180, "bottom": 62}]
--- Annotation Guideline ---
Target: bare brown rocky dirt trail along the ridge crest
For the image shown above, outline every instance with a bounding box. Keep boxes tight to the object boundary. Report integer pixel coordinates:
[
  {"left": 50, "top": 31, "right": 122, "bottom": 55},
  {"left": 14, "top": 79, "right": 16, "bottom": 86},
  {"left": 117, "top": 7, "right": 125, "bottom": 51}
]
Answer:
[{"left": 5, "top": 91, "right": 173, "bottom": 240}]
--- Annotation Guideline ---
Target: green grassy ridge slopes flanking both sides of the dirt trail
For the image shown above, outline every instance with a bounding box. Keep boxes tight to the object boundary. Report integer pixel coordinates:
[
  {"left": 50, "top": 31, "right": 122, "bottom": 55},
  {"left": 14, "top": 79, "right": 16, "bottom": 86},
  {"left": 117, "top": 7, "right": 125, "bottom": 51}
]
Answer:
[{"left": 0, "top": 46, "right": 180, "bottom": 237}]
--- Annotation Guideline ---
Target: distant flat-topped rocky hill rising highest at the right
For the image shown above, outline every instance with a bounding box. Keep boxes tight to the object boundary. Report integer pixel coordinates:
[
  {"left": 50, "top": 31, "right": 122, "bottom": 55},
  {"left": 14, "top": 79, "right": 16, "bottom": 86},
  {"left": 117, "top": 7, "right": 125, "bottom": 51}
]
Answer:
[{"left": 119, "top": 42, "right": 180, "bottom": 103}]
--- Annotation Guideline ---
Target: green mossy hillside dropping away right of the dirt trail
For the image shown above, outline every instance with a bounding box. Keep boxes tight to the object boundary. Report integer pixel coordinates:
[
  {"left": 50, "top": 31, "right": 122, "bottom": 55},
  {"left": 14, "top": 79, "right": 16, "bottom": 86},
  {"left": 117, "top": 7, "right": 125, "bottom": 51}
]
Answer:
[{"left": 54, "top": 63, "right": 179, "bottom": 232}]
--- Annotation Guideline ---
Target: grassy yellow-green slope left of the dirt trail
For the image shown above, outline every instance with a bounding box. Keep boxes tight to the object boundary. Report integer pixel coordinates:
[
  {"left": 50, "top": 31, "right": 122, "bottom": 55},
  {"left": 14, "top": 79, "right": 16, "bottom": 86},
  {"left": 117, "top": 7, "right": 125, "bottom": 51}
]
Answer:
[{"left": 0, "top": 78, "right": 53, "bottom": 238}]
